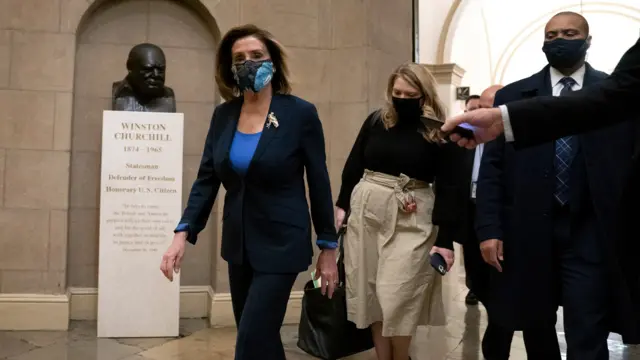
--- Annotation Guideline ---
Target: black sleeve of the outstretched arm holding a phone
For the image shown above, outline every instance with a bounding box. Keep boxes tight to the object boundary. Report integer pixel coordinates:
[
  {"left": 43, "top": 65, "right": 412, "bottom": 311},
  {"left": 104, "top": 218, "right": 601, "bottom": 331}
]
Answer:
[{"left": 507, "top": 39, "right": 640, "bottom": 147}]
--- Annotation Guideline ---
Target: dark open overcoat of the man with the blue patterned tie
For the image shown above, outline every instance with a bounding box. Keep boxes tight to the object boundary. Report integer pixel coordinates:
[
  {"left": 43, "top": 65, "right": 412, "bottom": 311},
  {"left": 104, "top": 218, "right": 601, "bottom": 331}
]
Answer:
[{"left": 476, "top": 64, "right": 635, "bottom": 330}]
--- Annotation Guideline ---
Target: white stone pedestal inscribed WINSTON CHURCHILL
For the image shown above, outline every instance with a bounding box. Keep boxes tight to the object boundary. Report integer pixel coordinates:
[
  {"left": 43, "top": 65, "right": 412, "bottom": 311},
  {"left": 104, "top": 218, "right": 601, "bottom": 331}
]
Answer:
[{"left": 98, "top": 111, "right": 184, "bottom": 337}]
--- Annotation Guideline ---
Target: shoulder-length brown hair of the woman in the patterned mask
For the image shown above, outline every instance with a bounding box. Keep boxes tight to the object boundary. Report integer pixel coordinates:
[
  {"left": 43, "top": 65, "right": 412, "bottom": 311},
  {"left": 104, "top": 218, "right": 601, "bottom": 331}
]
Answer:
[{"left": 216, "top": 24, "right": 291, "bottom": 101}]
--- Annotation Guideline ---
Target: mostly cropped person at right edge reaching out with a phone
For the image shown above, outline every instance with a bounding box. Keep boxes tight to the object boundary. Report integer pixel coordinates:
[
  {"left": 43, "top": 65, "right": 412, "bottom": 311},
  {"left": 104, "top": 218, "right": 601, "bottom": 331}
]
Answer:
[{"left": 442, "top": 36, "right": 640, "bottom": 343}]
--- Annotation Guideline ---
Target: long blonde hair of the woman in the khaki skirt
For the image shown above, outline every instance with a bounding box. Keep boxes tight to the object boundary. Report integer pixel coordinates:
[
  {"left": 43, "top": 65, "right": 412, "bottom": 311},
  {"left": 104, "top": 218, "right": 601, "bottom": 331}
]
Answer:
[{"left": 382, "top": 62, "right": 447, "bottom": 143}]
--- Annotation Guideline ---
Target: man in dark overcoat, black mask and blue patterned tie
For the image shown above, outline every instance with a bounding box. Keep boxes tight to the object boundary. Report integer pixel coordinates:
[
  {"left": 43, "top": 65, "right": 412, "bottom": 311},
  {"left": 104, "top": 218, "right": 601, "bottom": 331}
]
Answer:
[{"left": 476, "top": 12, "right": 635, "bottom": 360}]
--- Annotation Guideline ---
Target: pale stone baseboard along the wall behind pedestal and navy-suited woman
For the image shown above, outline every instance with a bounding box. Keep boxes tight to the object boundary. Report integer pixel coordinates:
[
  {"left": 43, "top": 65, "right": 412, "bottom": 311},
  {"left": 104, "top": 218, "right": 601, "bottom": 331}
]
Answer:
[{"left": 0, "top": 286, "right": 303, "bottom": 331}]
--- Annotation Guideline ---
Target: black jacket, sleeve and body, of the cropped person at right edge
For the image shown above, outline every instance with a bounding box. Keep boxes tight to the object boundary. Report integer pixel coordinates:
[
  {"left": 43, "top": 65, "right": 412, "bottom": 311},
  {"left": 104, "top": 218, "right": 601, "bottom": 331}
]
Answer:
[{"left": 498, "top": 39, "right": 640, "bottom": 344}]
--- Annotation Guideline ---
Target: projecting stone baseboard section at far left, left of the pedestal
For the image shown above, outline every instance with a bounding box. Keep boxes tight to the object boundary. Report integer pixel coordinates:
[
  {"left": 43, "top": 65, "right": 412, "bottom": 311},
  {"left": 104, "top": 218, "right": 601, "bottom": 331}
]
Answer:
[{"left": 0, "top": 294, "right": 69, "bottom": 331}]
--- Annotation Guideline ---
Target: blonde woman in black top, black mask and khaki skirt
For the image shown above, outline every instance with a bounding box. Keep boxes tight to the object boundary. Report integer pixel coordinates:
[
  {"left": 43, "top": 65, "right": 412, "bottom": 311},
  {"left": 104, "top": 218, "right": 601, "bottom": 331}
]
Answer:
[{"left": 336, "top": 63, "right": 467, "bottom": 360}]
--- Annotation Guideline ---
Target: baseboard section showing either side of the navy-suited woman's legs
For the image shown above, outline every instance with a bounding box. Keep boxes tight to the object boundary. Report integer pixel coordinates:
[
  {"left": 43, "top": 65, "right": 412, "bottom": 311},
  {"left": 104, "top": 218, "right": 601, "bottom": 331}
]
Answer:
[{"left": 209, "top": 291, "right": 304, "bottom": 327}]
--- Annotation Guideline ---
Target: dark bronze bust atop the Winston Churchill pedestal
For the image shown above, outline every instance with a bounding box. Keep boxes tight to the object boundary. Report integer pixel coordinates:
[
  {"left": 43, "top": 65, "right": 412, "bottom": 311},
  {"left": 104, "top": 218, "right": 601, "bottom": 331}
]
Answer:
[{"left": 111, "top": 43, "right": 176, "bottom": 113}]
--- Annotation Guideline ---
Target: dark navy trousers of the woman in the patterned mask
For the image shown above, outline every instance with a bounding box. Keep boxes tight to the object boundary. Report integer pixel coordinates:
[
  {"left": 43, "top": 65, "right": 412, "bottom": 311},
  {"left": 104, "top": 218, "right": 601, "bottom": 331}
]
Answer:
[{"left": 229, "top": 260, "right": 298, "bottom": 360}]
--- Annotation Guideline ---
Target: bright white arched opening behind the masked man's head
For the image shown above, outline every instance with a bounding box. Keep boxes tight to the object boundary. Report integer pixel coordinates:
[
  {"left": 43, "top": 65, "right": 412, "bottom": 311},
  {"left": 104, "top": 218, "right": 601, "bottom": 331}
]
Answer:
[{"left": 443, "top": 0, "right": 640, "bottom": 93}]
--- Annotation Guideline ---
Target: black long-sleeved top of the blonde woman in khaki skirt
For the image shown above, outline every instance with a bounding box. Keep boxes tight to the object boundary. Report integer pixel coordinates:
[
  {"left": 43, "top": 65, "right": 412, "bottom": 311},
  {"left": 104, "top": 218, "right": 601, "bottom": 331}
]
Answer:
[{"left": 336, "top": 111, "right": 466, "bottom": 248}]
